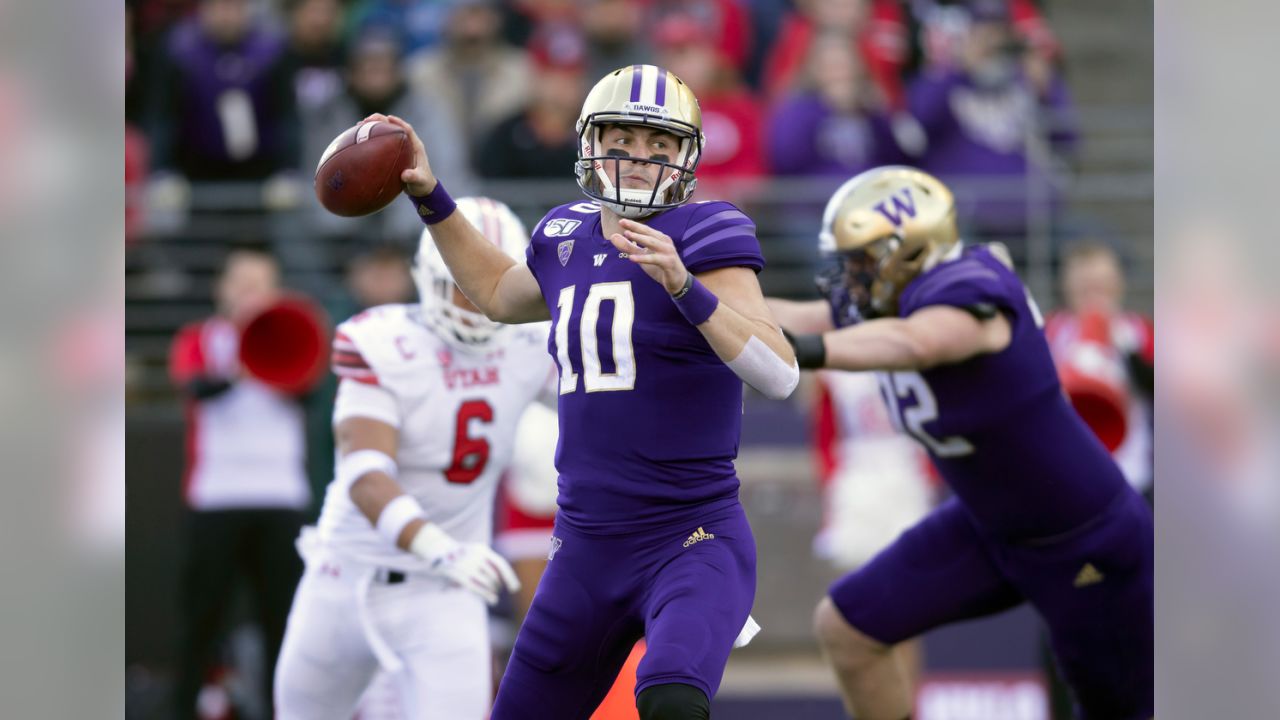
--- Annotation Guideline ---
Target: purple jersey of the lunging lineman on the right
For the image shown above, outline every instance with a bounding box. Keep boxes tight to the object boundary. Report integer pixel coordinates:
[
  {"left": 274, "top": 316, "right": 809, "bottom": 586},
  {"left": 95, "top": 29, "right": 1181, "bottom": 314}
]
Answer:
[{"left": 881, "top": 246, "right": 1125, "bottom": 539}]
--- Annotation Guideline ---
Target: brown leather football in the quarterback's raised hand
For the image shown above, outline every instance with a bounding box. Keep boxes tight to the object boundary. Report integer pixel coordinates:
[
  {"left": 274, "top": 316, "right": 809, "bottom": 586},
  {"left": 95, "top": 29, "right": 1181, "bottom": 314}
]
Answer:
[{"left": 315, "top": 120, "right": 413, "bottom": 218}]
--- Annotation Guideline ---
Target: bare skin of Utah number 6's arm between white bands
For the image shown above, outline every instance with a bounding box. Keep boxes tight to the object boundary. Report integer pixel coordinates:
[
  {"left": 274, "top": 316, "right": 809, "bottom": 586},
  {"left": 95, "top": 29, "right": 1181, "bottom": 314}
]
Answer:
[{"left": 334, "top": 416, "right": 426, "bottom": 551}]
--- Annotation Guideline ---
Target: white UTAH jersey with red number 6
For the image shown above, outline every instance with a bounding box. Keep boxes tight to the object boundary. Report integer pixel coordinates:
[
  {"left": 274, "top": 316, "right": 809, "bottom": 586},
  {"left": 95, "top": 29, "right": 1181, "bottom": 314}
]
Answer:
[{"left": 319, "top": 304, "right": 556, "bottom": 570}]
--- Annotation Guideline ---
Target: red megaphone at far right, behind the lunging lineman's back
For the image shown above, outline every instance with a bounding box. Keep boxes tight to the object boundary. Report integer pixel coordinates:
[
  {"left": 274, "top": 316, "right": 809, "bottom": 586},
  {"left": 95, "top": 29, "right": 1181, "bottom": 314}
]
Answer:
[{"left": 1057, "top": 313, "right": 1129, "bottom": 452}]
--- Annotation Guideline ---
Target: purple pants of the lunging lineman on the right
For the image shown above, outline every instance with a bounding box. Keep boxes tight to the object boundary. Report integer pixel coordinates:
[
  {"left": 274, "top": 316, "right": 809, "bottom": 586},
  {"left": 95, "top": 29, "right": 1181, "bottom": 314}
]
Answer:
[{"left": 829, "top": 488, "right": 1155, "bottom": 720}]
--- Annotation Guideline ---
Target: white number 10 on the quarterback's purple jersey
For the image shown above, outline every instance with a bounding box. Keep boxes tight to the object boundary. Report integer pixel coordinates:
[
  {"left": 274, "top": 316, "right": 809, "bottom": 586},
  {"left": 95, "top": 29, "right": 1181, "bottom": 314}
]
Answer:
[{"left": 556, "top": 281, "right": 636, "bottom": 395}]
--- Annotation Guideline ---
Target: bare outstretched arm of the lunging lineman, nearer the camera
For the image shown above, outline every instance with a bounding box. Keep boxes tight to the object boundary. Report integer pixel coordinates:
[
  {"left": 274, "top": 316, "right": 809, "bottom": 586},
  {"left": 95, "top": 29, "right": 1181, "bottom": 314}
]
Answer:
[{"left": 792, "top": 305, "right": 1012, "bottom": 370}]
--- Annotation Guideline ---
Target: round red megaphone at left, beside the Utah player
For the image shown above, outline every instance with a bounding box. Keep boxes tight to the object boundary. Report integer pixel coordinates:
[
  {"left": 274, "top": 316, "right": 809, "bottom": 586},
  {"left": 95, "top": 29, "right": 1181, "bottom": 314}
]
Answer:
[{"left": 239, "top": 295, "right": 329, "bottom": 395}]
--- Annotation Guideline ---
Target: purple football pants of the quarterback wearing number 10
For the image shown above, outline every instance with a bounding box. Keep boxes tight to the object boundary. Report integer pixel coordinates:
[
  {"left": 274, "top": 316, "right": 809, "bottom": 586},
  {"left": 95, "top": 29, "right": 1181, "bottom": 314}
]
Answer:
[{"left": 490, "top": 502, "right": 755, "bottom": 720}]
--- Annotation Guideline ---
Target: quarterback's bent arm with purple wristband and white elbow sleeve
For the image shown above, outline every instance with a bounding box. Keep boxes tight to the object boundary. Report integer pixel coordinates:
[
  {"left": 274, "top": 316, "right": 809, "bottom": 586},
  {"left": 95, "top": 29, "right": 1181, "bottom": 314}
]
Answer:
[{"left": 609, "top": 219, "right": 800, "bottom": 400}]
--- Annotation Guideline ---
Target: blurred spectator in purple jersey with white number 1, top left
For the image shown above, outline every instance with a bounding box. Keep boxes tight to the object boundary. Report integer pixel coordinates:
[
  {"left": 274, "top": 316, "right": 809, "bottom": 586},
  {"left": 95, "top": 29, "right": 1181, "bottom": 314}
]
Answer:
[{"left": 148, "top": 0, "right": 298, "bottom": 179}]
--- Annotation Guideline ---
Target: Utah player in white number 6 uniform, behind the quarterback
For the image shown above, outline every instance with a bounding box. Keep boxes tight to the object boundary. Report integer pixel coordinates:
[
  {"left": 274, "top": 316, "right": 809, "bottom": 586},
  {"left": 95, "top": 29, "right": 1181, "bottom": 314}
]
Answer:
[{"left": 275, "top": 197, "right": 556, "bottom": 720}]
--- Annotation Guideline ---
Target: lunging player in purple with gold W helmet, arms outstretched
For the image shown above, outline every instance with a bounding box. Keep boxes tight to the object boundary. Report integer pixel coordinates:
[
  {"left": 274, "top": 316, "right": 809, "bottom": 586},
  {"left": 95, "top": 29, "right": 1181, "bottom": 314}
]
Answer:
[{"left": 774, "top": 167, "right": 1155, "bottom": 720}]
